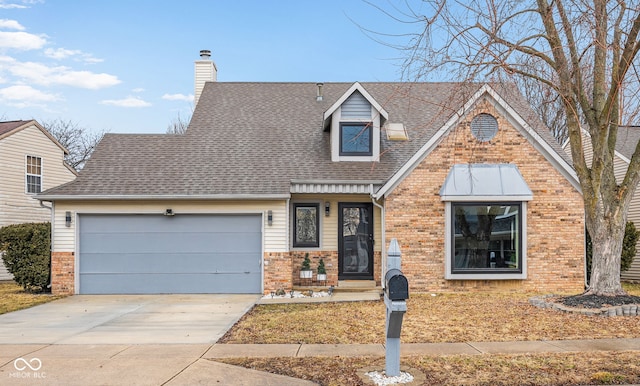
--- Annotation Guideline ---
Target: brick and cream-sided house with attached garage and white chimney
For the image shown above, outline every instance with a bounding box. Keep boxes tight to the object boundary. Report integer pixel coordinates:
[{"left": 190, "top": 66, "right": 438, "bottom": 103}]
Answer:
[{"left": 39, "top": 52, "right": 584, "bottom": 294}]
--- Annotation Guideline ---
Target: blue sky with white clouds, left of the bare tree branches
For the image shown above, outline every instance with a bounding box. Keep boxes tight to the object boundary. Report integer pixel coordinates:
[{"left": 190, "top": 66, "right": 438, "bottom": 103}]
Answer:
[{"left": 0, "top": 0, "right": 415, "bottom": 133}]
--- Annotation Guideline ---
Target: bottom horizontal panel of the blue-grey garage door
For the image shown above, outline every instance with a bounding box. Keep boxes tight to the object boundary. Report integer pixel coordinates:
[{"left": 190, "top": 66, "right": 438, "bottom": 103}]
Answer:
[{"left": 83, "top": 273, "right": 261, "bottom": 294}]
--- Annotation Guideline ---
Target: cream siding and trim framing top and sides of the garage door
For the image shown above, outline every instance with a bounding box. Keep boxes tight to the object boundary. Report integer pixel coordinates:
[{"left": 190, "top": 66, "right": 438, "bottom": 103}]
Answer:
[{"left": 53, "top": 200, "right": 288, "bottom": 252}]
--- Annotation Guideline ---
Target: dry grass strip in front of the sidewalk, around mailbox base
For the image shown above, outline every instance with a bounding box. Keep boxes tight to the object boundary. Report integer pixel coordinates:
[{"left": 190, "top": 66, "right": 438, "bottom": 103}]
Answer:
[{"left": 219, "top": 352, "right": 640, "bottom": 386}]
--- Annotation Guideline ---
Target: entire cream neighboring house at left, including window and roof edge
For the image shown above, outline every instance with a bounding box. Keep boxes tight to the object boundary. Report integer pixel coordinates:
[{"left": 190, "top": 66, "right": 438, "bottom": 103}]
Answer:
[{"left": 0, "top": 120, "right": 76, "bottom": 280}]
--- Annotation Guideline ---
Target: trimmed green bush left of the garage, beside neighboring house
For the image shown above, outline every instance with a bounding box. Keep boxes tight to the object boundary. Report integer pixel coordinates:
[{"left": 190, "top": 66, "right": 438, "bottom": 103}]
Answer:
[{"left": 0, "top": 223, "right": 51, "bottom": 292}]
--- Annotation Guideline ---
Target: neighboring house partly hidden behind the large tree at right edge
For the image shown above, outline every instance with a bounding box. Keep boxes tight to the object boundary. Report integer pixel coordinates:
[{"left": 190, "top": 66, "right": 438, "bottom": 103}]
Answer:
[{"left": 562, "top": 126, "right": 640, "bottom": 281}]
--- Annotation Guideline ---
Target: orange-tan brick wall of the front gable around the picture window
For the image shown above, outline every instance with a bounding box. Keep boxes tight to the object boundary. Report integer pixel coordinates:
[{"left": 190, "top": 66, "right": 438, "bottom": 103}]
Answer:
[{"left": 385, "top": 102, "right": 584, "bottom": 293}]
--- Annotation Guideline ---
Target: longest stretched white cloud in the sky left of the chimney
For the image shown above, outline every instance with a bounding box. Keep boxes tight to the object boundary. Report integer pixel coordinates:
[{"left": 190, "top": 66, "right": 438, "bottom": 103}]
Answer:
[{"left": 8, "top": 58, "right": 120, "bottom": 90}]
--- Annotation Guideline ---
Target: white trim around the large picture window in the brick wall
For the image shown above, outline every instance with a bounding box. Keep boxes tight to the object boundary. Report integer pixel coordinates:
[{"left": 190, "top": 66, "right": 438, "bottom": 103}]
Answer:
[{"left": 444, "top": 201, "right": 527, "bottom": 280}]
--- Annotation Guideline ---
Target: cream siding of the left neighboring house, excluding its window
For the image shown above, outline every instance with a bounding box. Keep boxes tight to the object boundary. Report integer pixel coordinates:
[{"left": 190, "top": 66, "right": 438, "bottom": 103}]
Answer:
[{"left": 0, "top": 126, "right": 75, "bottom": 280}]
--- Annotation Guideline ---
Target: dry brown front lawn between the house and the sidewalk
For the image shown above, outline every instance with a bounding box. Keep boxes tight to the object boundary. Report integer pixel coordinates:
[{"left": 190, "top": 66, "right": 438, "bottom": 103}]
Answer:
[{"left": 221, "top": 285, "right": 640, "bottom": 344}]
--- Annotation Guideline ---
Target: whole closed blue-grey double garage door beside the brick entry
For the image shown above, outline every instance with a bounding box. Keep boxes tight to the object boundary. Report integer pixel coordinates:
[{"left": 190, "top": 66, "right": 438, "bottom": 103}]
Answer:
[{"left": 78, "top": 214, "right": 262, "bottom": 294}]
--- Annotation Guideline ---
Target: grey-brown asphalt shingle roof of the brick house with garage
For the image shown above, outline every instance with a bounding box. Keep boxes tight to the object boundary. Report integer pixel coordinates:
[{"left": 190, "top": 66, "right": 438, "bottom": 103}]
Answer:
[{"left": 43, "top": 82, "right": 566, "bottom": 196}]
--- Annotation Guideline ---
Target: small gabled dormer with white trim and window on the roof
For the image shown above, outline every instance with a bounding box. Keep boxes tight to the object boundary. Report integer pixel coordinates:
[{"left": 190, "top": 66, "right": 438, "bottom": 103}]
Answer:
[{"left": 323, "top": 82, "right": 388, "bottom": 162}]
